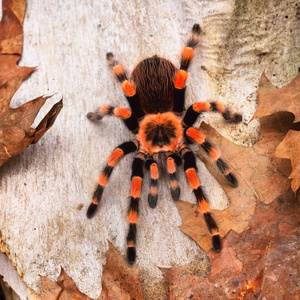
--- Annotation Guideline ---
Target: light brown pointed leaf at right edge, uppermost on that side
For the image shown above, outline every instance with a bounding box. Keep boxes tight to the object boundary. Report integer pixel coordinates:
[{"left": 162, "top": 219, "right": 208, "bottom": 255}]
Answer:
[{"left": 253, "top": 73, "right": 300, "bottom": 122}]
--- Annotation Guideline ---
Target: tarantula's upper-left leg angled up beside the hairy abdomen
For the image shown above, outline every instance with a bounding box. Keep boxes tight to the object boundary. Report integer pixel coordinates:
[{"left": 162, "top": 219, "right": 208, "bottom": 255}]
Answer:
[{"left": 106, "top": 52, "right": 145, "bottom": 119}]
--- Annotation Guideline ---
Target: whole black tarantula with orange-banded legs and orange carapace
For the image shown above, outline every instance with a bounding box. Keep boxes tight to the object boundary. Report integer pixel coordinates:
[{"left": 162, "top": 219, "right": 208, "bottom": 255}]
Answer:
[{"left": 87, "top": 24, "right": 242, "bottom": 263}]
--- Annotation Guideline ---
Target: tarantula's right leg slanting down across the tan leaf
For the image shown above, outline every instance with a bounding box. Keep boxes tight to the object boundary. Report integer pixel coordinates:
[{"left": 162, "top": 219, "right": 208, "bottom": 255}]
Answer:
[{"left": 185, "top": 127, "right": 238, "bottom": 187}]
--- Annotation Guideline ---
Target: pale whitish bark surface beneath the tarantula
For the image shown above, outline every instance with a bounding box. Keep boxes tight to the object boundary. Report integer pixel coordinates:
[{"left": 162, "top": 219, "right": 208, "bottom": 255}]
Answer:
[{"left": 0, "top": 0, "right": 300, "bottom": 299}]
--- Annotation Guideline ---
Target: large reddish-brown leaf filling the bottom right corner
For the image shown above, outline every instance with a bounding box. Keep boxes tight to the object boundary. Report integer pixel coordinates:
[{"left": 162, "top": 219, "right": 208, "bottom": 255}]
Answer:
[{"left": 162, "top": 190, "right": 300, "bottom": 300}]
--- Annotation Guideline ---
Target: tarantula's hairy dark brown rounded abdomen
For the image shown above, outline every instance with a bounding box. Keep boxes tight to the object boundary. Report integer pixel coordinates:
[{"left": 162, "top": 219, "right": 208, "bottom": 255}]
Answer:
[{"left": 132, "top": 55, "right": 176, "bottom": 114}]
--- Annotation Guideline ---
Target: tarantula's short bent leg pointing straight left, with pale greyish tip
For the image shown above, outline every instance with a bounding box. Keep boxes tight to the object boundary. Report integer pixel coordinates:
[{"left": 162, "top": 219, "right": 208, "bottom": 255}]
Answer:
[{"left": 87, "top": 105, "right": 139, "bottom": 132}]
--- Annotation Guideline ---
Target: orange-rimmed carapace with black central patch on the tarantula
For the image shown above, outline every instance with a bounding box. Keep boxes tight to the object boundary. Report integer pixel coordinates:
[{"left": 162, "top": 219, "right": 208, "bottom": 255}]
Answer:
[{"left": 137, "top": 112, "right": 183, "bottom": 154}]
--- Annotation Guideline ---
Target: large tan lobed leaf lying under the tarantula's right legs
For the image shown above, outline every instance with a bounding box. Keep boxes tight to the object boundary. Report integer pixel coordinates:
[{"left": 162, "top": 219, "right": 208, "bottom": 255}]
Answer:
[{"left": 176, "top": 113, "right": 296, "bottom": 251}]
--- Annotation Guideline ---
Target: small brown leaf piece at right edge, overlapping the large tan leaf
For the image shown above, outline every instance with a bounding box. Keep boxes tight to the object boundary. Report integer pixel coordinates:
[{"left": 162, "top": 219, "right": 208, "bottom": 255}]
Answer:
[{"left": 275, "top": 130, "right": 300, "bottom": 193}]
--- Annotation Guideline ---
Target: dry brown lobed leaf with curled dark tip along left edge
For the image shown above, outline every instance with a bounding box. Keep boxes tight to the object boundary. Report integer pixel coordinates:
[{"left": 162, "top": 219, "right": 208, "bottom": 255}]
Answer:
[{"left": 0, "top": 0, "right": 62, "bottom": 166}]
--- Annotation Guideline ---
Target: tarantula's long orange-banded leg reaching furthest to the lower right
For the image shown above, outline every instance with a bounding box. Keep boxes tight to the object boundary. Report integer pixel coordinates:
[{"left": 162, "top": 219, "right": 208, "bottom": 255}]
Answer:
[{"left": 180, "top": 147, "right": 222, "bottom": 252}]
